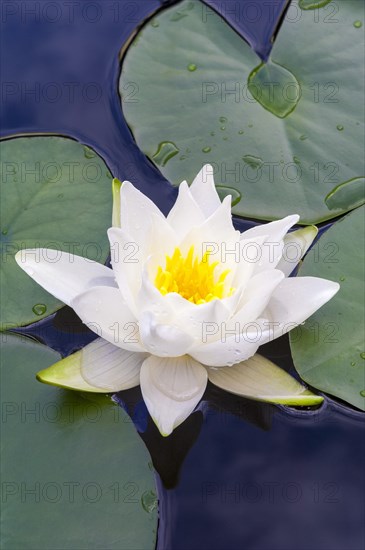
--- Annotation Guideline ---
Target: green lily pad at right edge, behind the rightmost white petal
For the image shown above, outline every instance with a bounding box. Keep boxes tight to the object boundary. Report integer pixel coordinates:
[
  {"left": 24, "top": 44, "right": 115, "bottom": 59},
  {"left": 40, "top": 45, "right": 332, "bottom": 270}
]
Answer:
[{"left": 290, "top": 207, "right": 365, "bottom": 410}]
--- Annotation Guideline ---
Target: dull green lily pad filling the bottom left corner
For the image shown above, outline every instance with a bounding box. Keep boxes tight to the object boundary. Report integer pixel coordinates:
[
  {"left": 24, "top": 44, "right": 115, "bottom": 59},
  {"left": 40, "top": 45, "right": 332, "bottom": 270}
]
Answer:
[{"left": 1, "top": 334, "right": 157, "bottom": 550}]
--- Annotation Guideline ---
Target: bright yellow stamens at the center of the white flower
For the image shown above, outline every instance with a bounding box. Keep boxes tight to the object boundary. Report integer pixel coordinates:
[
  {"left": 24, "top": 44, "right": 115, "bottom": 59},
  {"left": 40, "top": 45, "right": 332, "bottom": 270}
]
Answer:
[{"left": 155, "top": 246, "right": 234, "bottom": 305}]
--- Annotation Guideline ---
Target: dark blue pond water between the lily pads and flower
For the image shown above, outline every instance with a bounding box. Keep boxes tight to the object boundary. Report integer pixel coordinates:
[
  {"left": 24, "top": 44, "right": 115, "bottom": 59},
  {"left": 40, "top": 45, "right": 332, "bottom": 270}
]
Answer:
[{"left": 1, "top": 0, "right": 365, "bottom": 550}]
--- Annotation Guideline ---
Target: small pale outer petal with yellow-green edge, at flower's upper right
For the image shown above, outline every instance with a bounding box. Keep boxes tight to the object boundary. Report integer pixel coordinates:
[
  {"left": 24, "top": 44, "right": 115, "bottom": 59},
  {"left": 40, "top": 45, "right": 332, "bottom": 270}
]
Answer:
[{"left": 276, "top": 225, "right": 318, "bottom": 277}]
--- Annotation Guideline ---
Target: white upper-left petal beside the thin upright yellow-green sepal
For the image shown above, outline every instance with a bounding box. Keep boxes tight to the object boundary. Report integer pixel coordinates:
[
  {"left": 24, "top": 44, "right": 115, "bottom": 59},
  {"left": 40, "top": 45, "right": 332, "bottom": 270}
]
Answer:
[{"left": 120, "top": 181, "right": 164, "bottom": 246}]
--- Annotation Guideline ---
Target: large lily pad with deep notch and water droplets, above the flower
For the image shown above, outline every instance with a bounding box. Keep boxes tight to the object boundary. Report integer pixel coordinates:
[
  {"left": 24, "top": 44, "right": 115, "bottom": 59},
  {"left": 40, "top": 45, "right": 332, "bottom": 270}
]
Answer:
[{"left": 120, "top": 0, "right": 365, "bottom": 224}]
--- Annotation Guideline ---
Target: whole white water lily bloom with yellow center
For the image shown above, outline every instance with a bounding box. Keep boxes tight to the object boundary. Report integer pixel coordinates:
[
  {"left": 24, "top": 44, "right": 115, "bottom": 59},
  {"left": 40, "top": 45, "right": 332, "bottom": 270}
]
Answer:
[{"left": 16, "top": 165, "right": 339, "bottom": 435}]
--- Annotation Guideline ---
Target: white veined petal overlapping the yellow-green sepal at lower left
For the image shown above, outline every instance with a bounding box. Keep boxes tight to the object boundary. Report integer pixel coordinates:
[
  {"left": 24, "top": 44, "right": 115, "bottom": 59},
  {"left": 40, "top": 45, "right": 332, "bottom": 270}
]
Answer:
[{"left": 78, "top": 338, "right": 148, "bottom": 391}]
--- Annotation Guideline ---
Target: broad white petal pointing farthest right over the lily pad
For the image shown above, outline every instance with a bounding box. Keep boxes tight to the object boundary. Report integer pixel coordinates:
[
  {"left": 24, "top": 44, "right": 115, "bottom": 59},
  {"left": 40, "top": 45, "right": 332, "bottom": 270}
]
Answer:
[{"left": 263, "top": 277, "right": 340, "bottom": 339}]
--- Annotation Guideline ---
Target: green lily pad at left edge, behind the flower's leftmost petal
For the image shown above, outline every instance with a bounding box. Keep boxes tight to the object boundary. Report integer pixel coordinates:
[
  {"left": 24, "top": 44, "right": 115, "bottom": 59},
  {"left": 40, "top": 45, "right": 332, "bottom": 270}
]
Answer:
[{"left": 0, "top": 136, "right": 112, "bottom": 330}]
